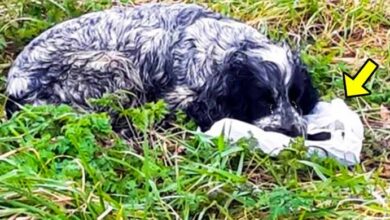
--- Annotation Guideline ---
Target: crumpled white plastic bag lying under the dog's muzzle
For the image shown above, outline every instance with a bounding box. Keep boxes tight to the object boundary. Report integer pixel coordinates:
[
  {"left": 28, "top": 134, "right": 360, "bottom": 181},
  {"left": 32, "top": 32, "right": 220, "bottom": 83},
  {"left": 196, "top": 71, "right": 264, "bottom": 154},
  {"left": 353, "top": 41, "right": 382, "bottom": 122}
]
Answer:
[{"left": 205, "top": 99, "right": 364, "bottom": 165}]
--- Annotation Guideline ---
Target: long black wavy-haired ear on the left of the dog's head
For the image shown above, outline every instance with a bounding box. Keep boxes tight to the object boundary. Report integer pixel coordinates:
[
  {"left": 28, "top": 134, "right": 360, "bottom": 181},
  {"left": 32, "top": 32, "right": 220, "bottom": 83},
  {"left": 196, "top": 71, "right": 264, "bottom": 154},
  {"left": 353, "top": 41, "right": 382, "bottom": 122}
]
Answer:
[{"left": 186, "top": 50, "right": 256, "bottom": 130}]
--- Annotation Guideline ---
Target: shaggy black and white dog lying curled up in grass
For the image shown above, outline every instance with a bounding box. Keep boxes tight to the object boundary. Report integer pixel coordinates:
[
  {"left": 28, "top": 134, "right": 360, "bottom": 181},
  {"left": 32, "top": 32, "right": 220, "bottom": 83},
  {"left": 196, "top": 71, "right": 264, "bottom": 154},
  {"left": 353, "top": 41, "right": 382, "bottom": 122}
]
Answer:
[{"left": 6, "top": 4, "right": 318, "bottom": 136}]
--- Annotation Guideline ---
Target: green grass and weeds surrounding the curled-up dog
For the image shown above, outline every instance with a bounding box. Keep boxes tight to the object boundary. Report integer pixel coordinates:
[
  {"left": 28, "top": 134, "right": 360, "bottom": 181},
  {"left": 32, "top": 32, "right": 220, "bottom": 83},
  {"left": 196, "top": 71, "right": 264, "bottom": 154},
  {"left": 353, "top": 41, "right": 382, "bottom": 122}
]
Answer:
[{"left": 0, "top": 0, "right": 390, "bottom": 219}]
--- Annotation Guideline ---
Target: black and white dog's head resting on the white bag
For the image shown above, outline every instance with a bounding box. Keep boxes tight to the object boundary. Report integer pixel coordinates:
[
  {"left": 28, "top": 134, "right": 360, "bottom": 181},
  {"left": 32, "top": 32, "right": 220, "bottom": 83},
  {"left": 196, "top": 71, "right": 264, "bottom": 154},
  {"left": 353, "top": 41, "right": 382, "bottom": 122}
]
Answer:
[{"left": 225, "top": 44, "right": 318, "bottom": 136}]
